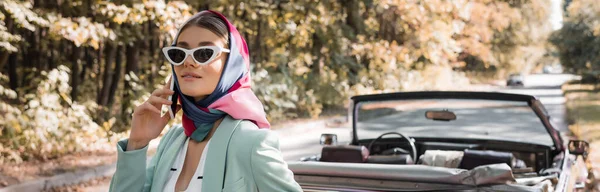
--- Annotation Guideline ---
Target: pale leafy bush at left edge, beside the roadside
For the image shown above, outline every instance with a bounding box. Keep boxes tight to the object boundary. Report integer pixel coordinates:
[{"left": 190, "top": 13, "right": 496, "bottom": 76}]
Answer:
[{"left": 0, "top": 66, "right": 122, "bottom": 162}]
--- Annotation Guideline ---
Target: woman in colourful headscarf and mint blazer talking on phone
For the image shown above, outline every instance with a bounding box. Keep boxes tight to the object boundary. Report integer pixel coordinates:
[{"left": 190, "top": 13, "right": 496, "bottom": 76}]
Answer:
[{"left": 110, "top": 11, "right": 301, "bottom": 192}]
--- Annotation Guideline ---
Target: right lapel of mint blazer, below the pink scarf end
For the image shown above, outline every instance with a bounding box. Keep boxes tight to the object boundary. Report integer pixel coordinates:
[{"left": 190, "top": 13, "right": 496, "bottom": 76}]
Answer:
[{"left": 202, "top": 116, "right": 241, "bottom": 191}]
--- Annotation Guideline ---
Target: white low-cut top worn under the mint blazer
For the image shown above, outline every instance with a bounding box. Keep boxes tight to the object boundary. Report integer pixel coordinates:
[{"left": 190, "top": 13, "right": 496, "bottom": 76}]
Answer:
[{"left": 163, "top": 137, "right": 210, "bottom": 192}]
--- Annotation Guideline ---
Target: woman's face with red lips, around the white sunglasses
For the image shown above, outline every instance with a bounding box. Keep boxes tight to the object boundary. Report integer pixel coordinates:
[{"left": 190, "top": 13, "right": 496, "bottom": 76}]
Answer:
[{"left": 175, "top": 26, "right": 228, "bottom": 101}]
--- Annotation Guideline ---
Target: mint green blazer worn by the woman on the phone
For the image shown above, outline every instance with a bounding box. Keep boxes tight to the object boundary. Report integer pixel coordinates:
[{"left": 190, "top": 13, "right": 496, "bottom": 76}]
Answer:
[{"left": 110, "top": 116, "right": 302, "bottom": 192}]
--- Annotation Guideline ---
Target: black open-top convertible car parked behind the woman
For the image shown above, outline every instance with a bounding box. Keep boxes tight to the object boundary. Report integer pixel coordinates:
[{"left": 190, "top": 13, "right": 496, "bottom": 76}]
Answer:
[{"left": 289, "top": 92, "right": 589, "bottom": 192}]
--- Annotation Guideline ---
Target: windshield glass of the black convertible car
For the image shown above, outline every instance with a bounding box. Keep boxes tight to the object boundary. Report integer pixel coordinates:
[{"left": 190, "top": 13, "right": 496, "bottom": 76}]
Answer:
[{"left": 355, "top": 99, "right": 553, "bottom": 146}]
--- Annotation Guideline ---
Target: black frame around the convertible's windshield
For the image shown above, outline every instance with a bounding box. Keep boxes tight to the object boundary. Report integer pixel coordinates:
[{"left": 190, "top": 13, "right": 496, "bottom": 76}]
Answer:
[{"left": 348, "top": 91, "right": 564, "bottom": 151}]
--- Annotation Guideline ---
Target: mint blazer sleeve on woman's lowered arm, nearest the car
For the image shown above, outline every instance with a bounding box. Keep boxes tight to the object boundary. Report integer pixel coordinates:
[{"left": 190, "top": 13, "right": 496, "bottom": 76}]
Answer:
[{"left": 250, "top": 130, "right": 302, "bottom": 191}]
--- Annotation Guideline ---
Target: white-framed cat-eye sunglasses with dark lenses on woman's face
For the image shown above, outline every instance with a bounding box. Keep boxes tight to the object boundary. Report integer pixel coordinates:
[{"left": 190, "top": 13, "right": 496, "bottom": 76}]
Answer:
[{"left": 163, "top": 46, "right": 229, "bottom": 66}]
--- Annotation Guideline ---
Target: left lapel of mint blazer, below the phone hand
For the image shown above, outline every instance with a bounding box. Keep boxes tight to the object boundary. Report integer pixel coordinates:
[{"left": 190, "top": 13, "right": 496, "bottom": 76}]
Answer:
[{"left": 152, "top": 131, "right": 187, "bottom": 191}]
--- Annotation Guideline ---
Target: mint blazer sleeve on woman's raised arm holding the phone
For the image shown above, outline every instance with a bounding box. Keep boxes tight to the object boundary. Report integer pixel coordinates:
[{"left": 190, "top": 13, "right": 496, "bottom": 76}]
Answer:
[{"left": 109, "top": 129, "right": 174, "bottom": 192}]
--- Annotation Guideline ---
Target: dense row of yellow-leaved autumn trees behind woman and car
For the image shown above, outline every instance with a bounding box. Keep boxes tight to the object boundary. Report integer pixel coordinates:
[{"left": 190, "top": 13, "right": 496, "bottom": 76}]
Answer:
[{"left": 0, "top": 0, "right": 552, "bottom": 162}]
